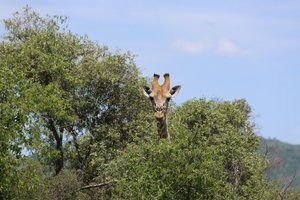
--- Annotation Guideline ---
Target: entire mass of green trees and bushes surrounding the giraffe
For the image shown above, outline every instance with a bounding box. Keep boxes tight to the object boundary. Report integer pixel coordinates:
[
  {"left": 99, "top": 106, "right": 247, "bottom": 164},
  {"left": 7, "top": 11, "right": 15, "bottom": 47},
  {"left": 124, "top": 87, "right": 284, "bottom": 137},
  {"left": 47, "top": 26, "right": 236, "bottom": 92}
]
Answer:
[{"left": 0, "top": 7, "right": 298, "bottom": 200}]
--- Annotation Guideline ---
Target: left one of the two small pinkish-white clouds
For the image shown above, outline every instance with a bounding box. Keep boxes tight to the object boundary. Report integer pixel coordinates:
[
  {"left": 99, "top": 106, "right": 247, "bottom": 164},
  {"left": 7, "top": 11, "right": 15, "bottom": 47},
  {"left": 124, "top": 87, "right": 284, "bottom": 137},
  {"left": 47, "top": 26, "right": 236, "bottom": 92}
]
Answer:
[{"left": 174, "top": 39, "right": 210, "bottom": 53}]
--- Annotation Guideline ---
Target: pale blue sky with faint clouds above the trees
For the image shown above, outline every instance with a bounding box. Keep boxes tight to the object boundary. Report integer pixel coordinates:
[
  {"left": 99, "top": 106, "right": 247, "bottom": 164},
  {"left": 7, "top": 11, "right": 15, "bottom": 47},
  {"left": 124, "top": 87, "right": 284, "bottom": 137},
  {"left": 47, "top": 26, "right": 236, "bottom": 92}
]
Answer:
[{"left": 0, "top": 0, "right": 300, "bottom": 144}]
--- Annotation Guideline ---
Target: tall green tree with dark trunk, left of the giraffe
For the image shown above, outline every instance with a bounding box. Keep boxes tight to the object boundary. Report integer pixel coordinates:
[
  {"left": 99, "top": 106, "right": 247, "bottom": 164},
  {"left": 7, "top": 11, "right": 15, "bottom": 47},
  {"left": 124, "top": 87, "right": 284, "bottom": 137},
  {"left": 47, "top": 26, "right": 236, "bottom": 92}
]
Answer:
[{"left": 0, "top": 7, "right": 151, "bottom": 198}]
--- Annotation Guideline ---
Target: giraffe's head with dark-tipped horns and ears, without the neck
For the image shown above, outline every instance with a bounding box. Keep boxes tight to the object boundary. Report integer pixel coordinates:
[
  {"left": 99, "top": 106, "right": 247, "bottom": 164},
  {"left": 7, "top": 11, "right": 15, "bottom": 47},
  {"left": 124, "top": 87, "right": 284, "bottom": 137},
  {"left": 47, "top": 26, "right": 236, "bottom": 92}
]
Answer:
[{"left": 144, "top": 73, "right": 181, "bottom": 120}]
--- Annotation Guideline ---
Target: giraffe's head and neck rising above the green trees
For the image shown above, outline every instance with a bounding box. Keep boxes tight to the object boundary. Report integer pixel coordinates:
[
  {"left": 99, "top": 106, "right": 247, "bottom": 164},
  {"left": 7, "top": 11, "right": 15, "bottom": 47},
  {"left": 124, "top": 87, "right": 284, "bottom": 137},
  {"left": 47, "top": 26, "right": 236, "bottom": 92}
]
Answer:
[{"left": 143, "top": 73, "right": 181, "bottom": 140}]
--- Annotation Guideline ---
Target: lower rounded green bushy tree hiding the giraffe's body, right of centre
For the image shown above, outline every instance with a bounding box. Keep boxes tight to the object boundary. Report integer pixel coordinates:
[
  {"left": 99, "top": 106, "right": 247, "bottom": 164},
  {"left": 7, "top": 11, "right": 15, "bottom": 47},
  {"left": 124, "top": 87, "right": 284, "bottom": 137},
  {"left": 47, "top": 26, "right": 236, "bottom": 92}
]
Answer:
[{"left": 112, "top": 99, "right": 267, "bottom": 199}]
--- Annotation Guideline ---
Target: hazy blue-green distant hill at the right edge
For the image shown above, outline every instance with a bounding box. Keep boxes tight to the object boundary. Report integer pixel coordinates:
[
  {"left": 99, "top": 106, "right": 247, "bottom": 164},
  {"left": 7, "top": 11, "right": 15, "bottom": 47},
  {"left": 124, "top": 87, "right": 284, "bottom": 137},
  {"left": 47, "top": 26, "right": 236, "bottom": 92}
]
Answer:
[{"left": 260, "top": 138, "right": 300, "bottom": 189}]
